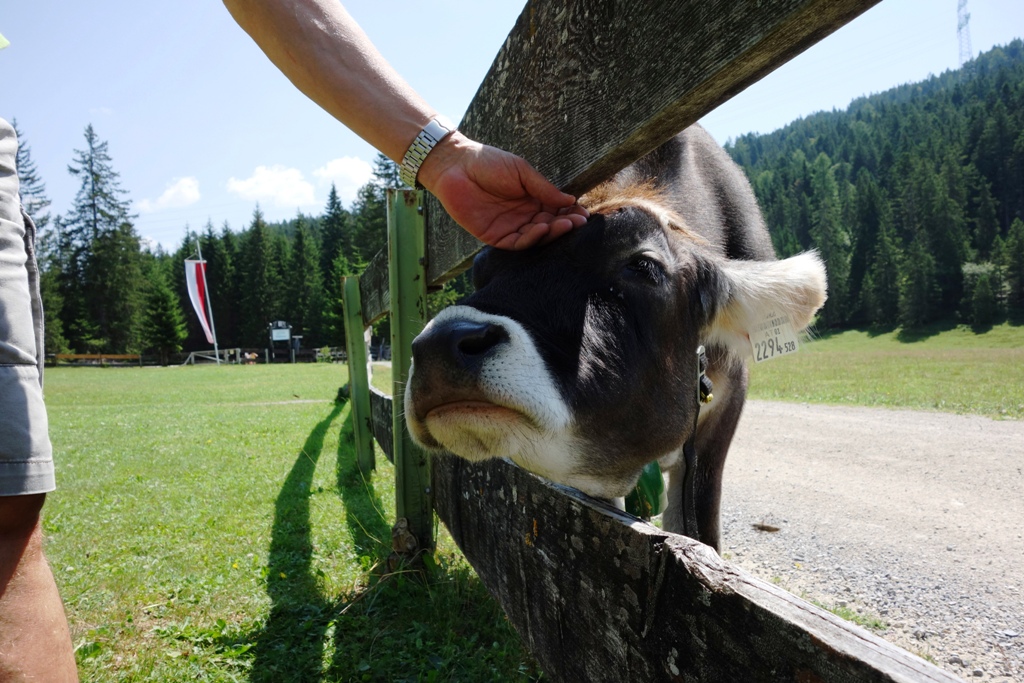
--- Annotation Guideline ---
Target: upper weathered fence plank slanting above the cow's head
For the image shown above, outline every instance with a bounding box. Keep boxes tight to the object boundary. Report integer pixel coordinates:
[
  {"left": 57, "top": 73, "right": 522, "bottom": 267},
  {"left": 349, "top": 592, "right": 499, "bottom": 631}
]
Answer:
[{"left": 427, "top": 0, "right": 879, "bottom": 285}]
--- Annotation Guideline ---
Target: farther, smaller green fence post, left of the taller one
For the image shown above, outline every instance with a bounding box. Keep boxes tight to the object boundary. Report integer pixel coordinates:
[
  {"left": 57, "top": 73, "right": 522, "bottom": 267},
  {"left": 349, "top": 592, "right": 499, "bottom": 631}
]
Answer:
[{"left": 342, "top": 275, "right": 376, "bottom": 474}]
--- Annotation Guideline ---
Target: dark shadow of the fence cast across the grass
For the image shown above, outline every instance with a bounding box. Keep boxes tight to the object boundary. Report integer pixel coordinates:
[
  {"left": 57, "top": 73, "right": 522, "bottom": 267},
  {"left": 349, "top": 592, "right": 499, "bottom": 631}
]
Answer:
[{"left": 245, "top": 405, "right": 540, "bottom": 683}]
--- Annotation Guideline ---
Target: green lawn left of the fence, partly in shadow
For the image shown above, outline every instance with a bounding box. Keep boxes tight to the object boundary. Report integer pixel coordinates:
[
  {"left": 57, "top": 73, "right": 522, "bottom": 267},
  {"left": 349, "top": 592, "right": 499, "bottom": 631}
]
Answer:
[{"left": 44, "top": 365, "right": 540, "bottom": 682}]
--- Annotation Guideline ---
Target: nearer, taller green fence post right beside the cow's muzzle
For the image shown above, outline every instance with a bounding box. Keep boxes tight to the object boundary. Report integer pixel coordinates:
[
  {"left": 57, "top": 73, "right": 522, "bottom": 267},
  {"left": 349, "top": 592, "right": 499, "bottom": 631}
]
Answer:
[{"left": 387, "top": 189, "right": 434, "bottom": 555}]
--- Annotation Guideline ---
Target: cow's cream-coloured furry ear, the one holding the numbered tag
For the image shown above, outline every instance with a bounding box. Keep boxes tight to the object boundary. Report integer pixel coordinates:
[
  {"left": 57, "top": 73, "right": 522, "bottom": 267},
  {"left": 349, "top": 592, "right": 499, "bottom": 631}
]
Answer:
[{"left": 706, "top": 252, "right": 826, "bottom": 355}]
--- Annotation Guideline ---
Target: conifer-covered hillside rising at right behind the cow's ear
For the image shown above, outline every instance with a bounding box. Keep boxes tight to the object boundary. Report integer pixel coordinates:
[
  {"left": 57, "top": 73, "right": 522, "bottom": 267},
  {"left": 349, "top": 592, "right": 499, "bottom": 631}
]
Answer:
[{"left": 726, "top": 40, "right": 1024, "bottom": 327}]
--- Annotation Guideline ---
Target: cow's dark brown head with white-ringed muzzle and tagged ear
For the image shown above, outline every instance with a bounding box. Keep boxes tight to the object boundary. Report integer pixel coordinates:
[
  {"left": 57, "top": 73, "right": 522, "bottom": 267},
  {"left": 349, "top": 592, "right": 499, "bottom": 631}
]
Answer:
[{"left": 406, "top": 189, "right": 824, "bottom": 498}]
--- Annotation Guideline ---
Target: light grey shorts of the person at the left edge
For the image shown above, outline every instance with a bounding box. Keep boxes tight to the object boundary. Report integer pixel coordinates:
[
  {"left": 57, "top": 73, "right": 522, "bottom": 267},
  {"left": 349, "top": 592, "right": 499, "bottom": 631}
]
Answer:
[{"left": 0, "top": 119, "right": 55, "bottom": 496}]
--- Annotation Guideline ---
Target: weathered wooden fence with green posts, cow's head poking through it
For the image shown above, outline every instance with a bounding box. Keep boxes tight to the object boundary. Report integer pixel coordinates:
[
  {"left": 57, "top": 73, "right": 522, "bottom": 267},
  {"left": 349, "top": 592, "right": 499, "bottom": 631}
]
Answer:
[{"left": 344, "top": 0, "right": 958, "bottom": 682}]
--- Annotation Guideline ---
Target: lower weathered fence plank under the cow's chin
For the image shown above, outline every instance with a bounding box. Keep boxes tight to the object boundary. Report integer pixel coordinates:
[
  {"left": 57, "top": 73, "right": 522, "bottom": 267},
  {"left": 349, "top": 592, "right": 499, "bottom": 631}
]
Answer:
[{"left": 433, "top": 456, "right": 959, "bottom": 683}]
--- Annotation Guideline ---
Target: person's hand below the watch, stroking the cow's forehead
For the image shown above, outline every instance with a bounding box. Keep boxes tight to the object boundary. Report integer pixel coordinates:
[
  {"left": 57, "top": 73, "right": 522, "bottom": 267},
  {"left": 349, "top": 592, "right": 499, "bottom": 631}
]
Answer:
[{"left": 419, "top": 131, "right": 590, "bottom": 250}]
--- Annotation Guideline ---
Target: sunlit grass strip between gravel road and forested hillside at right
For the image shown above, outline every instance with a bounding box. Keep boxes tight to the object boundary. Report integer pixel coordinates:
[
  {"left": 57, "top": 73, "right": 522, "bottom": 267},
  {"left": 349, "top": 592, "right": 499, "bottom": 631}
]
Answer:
[{"left": 750, "top": 324, "right": 1024, "bottom": 419}]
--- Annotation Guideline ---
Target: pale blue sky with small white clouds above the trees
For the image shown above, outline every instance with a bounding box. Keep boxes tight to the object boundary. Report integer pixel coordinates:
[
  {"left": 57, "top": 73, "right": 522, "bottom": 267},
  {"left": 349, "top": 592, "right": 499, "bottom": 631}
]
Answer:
[{"left": 0, "top": 0, "right": 1024, "bottom": 249}]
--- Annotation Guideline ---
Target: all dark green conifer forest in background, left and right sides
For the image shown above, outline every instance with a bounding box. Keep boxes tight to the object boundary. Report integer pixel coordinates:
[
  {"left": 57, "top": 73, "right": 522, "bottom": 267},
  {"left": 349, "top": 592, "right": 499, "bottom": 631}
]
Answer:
[{"left": 15, "top": 40, "right": 1024, "bottom": 362}]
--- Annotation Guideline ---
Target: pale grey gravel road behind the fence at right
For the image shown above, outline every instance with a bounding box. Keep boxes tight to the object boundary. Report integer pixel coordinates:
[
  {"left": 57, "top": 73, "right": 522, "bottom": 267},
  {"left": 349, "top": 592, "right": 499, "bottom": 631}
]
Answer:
[{"left": 722, "top": 401, "right": 1024, "bottom": 681}]
